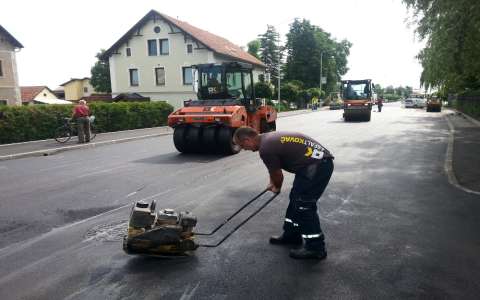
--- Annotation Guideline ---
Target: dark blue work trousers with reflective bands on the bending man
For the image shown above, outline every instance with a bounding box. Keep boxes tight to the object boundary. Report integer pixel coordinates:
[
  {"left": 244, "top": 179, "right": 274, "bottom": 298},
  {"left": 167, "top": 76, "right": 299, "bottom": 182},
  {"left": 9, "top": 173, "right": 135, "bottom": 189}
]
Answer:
[{"left": 283, "top": 159, "right": 333, "bottom": 250}]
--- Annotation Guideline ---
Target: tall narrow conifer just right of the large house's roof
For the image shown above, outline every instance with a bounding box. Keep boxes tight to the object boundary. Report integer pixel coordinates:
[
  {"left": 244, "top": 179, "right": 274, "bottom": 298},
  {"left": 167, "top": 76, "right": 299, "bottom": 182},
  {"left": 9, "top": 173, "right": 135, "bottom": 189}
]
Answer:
[{"left": 258, "top": 25, "right": 282, "bottom": 82}]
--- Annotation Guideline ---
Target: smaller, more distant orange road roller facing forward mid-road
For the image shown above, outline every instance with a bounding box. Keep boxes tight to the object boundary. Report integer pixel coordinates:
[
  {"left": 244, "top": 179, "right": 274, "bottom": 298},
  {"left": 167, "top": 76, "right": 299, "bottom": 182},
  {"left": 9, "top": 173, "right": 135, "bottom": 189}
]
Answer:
[{"left": 341, "top": 79, "right": 376, "bottom": 122}]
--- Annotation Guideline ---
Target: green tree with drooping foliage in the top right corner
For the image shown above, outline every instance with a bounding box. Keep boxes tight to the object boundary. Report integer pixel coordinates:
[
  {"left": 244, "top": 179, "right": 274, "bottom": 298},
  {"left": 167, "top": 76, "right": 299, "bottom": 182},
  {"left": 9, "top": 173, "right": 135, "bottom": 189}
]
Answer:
[{"left": 403, "top": 0, "right": 480, "bottom": 93}]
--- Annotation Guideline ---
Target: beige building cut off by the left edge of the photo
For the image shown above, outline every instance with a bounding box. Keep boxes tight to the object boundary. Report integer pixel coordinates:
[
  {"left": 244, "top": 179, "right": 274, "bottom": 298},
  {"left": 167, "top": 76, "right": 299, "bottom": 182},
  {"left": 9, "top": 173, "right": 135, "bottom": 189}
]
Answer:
[{"left": 0, "top": 25, "right": 23, "bottom": 105}]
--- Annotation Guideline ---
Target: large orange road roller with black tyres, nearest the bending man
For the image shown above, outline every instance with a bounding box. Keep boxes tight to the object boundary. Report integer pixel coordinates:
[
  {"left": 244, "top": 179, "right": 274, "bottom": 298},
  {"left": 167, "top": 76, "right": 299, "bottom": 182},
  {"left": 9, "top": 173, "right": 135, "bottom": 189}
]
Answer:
[{"left": 168, "top": 62, "right": 277, "bottom": 154}]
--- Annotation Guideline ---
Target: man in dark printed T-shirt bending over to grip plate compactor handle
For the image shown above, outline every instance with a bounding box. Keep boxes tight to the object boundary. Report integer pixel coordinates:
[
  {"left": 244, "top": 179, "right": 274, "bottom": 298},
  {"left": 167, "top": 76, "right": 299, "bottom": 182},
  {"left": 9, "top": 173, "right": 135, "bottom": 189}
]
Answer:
[{"left": 233, "top": 126, "right": 333, "bottom": 259}]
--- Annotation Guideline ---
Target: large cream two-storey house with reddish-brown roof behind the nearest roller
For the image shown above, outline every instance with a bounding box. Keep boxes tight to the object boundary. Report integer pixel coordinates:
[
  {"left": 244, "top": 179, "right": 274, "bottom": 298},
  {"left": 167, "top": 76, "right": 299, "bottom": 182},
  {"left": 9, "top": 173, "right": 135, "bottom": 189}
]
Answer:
[{"left": 102, "top": 10, "right": 265, "bottom": 108}]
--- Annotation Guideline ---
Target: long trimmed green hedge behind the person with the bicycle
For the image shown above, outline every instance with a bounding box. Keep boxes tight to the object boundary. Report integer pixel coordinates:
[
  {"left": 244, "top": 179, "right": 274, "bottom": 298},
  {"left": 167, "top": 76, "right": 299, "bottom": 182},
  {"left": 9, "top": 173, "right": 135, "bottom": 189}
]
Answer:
[{"left": 0, "top": 101, "right": 173, "bottom": 144}]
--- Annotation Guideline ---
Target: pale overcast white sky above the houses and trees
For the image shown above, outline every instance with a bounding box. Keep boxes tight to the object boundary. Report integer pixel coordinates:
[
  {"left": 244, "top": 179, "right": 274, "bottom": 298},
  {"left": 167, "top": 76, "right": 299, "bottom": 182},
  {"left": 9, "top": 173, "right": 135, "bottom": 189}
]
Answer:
[{"left": 0, "top": 0, "right": 423, "bottom": 89}]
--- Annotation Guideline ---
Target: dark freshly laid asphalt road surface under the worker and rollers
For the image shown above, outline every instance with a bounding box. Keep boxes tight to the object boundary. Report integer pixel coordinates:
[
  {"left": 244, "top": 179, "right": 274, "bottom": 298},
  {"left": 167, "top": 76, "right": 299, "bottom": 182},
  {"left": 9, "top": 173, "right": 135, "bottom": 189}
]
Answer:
[{"left": 0, "top": 104, "right": 480, "bottom": 299}]
